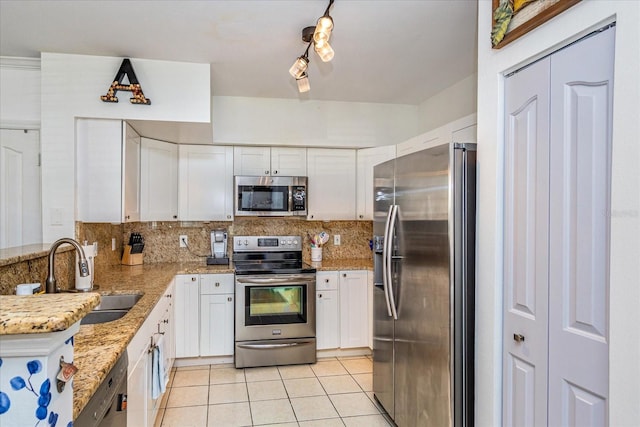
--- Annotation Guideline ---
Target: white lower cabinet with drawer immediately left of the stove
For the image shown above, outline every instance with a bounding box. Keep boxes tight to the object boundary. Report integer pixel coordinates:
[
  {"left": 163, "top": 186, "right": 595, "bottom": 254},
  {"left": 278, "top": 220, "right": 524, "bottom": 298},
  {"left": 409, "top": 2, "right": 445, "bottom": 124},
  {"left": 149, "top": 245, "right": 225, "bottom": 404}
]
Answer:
[{"left": 200, "top": 274, "right": 235, "bottom": 356}]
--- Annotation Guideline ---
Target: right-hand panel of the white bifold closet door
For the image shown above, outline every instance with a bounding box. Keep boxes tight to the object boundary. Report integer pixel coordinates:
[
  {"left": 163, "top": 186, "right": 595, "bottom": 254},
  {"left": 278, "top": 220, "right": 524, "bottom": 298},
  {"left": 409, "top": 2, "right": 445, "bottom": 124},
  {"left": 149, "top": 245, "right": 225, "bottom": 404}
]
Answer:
[{"left": 549, "top": 28, "right": 615, "bottom": 427}]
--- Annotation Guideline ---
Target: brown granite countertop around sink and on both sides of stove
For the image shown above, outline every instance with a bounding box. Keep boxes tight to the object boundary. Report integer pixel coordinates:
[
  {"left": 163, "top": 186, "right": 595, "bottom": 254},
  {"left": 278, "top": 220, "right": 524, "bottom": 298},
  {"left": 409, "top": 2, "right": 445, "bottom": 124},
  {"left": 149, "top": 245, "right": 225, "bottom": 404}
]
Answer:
[{"left": 6, "top": 259, "right": 372, "bottom": 419}]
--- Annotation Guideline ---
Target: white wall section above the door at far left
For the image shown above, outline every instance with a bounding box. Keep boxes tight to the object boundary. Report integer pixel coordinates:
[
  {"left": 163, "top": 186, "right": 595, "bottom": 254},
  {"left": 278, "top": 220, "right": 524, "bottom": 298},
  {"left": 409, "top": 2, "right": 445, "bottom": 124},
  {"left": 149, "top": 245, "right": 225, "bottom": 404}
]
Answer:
[{"left": 0, "top": 56, "right": 40, "bottom": 129}]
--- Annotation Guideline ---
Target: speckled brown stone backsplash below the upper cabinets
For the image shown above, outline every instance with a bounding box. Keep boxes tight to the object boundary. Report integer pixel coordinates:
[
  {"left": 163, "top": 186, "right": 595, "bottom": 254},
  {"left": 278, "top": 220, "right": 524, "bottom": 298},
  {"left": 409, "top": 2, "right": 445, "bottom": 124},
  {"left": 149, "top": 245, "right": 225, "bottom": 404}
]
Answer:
[{"left": 0, "top": 217, "right": 373, "bottom": 295}]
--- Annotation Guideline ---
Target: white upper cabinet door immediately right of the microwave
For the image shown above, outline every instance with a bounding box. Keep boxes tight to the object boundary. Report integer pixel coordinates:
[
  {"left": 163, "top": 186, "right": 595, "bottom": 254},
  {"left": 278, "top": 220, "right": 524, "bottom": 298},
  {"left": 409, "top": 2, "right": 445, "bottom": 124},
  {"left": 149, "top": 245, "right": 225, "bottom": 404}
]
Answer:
[{"left": 307, "top": 148, "right": 356, "bottom": 220}]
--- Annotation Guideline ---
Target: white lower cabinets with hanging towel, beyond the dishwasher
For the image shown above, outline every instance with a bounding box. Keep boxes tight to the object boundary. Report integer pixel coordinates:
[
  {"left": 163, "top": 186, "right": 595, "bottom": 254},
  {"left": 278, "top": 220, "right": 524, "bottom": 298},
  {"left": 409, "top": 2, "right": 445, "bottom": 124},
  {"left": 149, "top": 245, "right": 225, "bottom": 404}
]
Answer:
[{"left": 127, "top": 282, "right": 174, "bottom": 427}]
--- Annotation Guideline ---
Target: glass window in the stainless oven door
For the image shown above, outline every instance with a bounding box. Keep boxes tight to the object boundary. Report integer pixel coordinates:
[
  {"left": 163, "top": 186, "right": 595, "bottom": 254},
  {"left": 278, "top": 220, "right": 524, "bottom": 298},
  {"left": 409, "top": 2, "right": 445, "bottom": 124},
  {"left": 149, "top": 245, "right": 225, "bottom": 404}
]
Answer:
[{"left": 245, "top": 285, "right": 307, "bottom": 326}]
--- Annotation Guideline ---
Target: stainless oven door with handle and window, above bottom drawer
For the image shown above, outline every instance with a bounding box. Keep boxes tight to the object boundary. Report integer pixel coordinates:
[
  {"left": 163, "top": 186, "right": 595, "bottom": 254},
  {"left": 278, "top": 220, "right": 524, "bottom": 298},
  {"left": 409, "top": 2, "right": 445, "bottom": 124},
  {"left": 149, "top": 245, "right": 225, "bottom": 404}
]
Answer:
[{"left": 235, "top": 274, "right": 316, "bottom": 341}]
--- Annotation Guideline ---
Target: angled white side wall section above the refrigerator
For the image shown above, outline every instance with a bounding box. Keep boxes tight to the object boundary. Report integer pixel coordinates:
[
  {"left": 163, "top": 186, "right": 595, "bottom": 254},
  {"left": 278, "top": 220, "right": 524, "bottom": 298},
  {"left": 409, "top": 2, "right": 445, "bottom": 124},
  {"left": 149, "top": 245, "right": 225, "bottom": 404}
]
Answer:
[{"left": 418, "top": 74, "right": 478, "bottom": 133}]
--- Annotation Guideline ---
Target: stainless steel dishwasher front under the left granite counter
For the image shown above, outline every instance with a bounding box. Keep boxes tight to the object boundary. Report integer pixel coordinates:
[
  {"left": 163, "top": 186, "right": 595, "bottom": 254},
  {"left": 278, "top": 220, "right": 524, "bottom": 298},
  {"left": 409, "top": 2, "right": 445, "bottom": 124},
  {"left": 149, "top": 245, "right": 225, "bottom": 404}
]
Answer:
[{"left": 73, "top": 351, "right": 128, "bottom": 427}]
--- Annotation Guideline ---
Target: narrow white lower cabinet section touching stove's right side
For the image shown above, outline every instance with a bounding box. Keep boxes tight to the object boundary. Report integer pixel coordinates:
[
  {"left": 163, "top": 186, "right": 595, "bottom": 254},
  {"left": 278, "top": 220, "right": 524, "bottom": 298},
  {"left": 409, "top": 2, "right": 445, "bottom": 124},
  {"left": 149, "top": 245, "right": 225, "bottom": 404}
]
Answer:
[{"left": 316, "top": 271, "right": 340, "bottom": 350}]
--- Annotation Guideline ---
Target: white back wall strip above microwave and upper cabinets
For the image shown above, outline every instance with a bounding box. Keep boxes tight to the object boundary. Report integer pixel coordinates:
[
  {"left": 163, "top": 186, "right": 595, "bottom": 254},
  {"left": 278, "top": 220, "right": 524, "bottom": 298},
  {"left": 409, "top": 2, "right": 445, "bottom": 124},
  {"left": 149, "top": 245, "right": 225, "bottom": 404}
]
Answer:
[{"left": 212, "top": 96, "right": 418, "bottom": 148}]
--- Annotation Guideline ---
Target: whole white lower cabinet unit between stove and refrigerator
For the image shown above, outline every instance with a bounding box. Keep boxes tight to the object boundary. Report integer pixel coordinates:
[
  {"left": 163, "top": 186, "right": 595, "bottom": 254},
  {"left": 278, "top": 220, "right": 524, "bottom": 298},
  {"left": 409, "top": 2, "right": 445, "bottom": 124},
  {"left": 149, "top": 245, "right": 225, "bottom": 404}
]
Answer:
[{"left": 316, "top": 270, "right": 371, "bottom": 350}]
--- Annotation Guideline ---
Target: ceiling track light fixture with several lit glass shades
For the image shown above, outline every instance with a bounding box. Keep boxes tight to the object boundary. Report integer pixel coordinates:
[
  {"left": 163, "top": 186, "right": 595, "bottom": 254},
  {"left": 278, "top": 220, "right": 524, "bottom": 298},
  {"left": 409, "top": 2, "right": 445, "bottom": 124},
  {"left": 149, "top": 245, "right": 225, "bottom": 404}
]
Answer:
[{"left": 289, "top": 0, "right": 335, "bottom": 93}]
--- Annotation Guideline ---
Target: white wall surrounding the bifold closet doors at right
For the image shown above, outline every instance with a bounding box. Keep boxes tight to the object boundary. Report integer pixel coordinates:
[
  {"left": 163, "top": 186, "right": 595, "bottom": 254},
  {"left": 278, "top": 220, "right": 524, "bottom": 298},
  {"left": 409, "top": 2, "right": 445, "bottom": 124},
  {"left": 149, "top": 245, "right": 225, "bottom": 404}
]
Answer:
[{"left": 476, "top": 0, "right": 640, "bottom": 427}]
